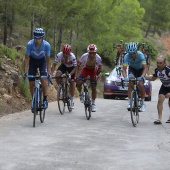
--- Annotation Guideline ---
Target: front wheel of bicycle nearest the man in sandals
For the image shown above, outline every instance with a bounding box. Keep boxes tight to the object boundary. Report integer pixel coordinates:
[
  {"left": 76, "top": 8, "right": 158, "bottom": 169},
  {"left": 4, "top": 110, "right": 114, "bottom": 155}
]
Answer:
[{"left": 130, "top": 91, "right": 139, "bottom": 127}]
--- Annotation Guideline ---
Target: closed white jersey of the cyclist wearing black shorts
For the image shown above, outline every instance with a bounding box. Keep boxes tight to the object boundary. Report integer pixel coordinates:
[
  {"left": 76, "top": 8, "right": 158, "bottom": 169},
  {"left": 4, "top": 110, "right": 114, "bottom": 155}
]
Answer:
[{"left": 54, "top": 52, "right": 77, "bottom": 67}]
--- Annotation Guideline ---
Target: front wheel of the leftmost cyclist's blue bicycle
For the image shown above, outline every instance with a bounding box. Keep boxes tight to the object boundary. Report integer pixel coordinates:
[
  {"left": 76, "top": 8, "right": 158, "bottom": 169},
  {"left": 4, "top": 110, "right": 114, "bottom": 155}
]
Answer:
[{"left": 32, "top": 88, "right": 38, "bottom": 127}]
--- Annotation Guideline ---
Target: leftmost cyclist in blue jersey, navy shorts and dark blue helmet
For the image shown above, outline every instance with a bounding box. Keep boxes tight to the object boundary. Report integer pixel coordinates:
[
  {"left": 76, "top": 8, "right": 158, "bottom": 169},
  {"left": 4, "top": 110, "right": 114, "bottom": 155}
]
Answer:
[{"left": 23, "top": 28, "right": 51, "bottom": 112}]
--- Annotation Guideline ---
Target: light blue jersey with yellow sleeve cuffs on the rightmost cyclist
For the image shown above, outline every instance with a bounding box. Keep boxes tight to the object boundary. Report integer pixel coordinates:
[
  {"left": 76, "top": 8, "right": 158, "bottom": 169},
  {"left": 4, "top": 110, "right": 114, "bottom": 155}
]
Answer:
[{"left": 123, "top": 51, "right": 146, "bottom": 70}]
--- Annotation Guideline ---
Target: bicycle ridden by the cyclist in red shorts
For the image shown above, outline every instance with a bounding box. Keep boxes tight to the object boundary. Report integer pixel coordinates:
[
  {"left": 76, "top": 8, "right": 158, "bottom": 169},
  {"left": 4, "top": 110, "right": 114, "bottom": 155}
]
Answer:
[{"left": 82, "top": 76, "right": 92, "bottom": 120}]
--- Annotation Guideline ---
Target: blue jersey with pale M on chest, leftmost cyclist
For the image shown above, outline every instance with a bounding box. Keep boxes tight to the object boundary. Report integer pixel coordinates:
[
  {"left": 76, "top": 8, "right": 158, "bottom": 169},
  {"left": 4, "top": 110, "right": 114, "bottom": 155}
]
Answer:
[{"left": 26, "top": 39, "right": 51, "bottom": 59}]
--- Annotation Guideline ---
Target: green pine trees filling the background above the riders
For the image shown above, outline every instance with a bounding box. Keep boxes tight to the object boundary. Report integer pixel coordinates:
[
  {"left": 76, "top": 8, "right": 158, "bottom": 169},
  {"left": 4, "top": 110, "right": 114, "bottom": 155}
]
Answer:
[{"left": 0, "top": 0, "right": 170, "bottom": 63}]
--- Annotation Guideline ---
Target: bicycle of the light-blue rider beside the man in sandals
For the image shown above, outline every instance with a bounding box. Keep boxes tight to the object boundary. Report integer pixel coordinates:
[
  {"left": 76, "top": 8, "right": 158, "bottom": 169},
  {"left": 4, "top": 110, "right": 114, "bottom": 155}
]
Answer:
[{"left": 121, "top": 77, "right": 144, "bottom": 127}]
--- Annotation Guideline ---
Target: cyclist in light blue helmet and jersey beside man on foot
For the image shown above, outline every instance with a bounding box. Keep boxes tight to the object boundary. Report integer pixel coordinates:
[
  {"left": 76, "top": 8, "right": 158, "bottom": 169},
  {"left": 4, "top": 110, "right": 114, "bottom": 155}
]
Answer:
[{"left": 123, "top": 42, "right": 147, "bottom": 112}]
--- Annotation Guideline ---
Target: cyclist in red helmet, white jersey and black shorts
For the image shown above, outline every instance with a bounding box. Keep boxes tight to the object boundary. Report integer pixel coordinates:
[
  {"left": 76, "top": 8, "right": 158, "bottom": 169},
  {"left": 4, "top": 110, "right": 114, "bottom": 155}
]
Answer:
[{"left": 51, "top": 44, "right": 77, "bottom": 109}]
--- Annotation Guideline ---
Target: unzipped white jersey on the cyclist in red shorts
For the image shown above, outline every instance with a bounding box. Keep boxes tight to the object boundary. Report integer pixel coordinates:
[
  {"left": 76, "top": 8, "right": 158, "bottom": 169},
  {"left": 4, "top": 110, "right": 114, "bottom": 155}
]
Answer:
[{"left": 78, "top": 53, "right": 102, "bottom": 68}]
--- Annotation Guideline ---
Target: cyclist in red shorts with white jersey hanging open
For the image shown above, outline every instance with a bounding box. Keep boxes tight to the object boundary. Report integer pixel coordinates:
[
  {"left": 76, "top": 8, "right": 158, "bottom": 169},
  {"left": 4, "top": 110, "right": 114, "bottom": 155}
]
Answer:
[{"left": 77, "top": 44, "right": 102, "bottom": 112}]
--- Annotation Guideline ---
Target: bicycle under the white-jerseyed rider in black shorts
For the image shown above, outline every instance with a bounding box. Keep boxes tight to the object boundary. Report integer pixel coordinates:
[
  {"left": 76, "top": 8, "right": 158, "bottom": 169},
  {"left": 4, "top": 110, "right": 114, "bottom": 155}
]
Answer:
[{"left": 53, "top": 72, "right": 72, "bottom": 115}]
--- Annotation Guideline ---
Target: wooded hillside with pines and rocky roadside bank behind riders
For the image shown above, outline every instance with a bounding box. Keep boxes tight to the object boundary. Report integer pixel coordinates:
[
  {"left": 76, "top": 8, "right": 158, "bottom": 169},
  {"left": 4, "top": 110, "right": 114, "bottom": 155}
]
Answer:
[{"left": 0, "top": 0, "right": 170, "bottom": 115}]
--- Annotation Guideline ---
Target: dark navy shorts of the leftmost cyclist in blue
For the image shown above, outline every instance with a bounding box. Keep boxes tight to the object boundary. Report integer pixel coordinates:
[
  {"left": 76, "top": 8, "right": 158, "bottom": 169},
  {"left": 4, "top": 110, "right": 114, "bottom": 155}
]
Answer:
[{"left": 28, "top": 57, "right": 47, "bottom": 81}]
